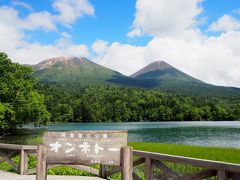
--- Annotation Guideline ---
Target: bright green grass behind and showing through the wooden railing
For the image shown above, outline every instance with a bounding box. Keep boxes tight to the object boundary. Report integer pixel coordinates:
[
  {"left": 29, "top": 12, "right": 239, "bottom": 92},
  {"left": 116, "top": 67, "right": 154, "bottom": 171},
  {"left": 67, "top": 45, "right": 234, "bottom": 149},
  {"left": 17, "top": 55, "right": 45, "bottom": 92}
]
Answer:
[{"left": 0, "top": 142, "right": 240, "bottom": 179}]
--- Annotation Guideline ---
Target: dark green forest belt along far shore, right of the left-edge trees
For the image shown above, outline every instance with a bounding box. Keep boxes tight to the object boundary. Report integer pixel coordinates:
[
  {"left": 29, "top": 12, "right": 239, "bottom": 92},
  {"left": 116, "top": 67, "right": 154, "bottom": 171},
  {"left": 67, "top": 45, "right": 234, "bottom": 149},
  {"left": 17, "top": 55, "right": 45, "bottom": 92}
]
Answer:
[{"left": 38, "top": 85, "right": 240, "bottom": 122}]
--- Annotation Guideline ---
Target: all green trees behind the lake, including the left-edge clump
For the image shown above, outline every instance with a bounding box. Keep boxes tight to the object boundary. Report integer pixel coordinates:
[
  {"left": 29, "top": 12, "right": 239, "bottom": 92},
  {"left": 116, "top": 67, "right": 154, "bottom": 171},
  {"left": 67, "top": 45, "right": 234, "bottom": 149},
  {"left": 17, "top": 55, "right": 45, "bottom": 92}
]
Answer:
[{"left": 0, "top": 53, "right": 240, "bottom": 133}]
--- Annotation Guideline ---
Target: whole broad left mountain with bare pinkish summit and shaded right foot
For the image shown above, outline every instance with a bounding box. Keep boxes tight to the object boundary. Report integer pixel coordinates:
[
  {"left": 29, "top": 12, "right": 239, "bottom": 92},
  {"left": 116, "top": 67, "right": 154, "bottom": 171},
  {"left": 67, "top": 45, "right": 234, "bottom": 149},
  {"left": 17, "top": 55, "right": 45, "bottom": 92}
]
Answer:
[{"left": 32, "top": 56, "right": 153, "bottom": 88}]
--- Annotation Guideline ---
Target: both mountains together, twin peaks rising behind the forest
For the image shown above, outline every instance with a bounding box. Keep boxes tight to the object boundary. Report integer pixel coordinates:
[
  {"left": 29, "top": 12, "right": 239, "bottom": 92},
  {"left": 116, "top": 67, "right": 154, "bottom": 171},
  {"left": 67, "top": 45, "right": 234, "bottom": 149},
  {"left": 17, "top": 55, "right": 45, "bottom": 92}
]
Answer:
[{"left": 32, "top": 57, "right": 240, "bottom": 96}]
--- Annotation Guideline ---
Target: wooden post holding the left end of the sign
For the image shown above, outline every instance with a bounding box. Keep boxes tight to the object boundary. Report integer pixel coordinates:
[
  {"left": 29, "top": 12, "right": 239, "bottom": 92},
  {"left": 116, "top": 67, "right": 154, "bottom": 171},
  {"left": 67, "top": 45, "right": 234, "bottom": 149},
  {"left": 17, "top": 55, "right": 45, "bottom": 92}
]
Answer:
[{"left": 36, "top": 145, "right": 47, "bottom": 180}]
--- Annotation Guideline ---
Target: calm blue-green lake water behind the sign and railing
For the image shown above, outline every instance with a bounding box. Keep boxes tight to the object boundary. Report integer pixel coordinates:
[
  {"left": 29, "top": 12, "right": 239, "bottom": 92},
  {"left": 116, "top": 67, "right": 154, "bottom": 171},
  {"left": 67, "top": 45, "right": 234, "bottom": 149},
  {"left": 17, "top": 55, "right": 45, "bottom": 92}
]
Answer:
[{"left": 0, "top": 121, "right": 240, "bottom": 148}]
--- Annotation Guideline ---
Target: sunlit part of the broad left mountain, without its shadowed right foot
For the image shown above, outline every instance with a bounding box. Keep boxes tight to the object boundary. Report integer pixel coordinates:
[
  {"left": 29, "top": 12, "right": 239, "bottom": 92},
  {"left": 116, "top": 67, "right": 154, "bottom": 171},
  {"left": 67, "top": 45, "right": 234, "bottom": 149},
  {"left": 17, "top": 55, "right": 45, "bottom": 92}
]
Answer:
[{"left": 32, "top": 57, "right": 123, "bottom": 87}]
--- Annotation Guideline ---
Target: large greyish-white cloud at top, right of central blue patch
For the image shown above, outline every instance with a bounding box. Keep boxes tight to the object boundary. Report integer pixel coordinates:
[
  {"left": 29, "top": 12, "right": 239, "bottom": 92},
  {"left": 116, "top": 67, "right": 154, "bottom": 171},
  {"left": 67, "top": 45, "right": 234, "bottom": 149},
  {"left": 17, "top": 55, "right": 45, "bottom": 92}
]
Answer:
[{"left": 128, "top": 0, "right": 202, "bottom": 37}]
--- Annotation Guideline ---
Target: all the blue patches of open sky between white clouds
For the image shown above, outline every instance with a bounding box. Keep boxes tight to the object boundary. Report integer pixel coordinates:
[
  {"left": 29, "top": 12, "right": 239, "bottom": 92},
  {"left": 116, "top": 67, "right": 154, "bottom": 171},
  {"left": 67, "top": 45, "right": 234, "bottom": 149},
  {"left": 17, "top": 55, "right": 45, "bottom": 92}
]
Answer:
[{"left": 0, "top": 0, "right": 240, "bottom": 45}]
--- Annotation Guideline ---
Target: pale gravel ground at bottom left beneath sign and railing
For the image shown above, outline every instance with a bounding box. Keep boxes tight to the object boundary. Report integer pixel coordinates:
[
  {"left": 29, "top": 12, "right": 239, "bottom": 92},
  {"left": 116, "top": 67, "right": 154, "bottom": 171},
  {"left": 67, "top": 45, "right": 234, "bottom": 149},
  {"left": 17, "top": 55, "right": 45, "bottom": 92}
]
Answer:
[{"left": 0, "top": 171, "right": 102, "bottom": 180}]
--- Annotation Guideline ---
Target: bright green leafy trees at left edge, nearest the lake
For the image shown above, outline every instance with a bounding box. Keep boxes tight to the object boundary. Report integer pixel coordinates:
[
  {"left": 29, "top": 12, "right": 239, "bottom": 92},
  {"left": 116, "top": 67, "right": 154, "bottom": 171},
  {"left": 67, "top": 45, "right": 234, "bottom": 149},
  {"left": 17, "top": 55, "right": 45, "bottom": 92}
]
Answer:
[{"left": 0, "top": 53, "right": 50, "bottom": 134}]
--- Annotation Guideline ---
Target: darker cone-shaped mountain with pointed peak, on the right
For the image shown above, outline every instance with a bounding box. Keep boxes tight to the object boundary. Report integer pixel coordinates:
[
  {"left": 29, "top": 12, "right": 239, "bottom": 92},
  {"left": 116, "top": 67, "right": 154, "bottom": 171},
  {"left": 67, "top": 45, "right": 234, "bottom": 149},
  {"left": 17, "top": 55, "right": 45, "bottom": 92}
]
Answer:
[{"left": 130, "top": 61, "right": 240, "bottom": 96}]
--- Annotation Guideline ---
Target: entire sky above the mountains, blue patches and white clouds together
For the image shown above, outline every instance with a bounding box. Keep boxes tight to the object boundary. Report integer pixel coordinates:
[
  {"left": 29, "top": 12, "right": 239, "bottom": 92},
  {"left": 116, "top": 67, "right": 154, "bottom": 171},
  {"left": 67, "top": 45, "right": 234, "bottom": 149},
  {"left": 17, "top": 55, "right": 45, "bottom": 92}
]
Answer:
[{"left": 0, "top": 0, "right": 240, "bottom": 87}]
